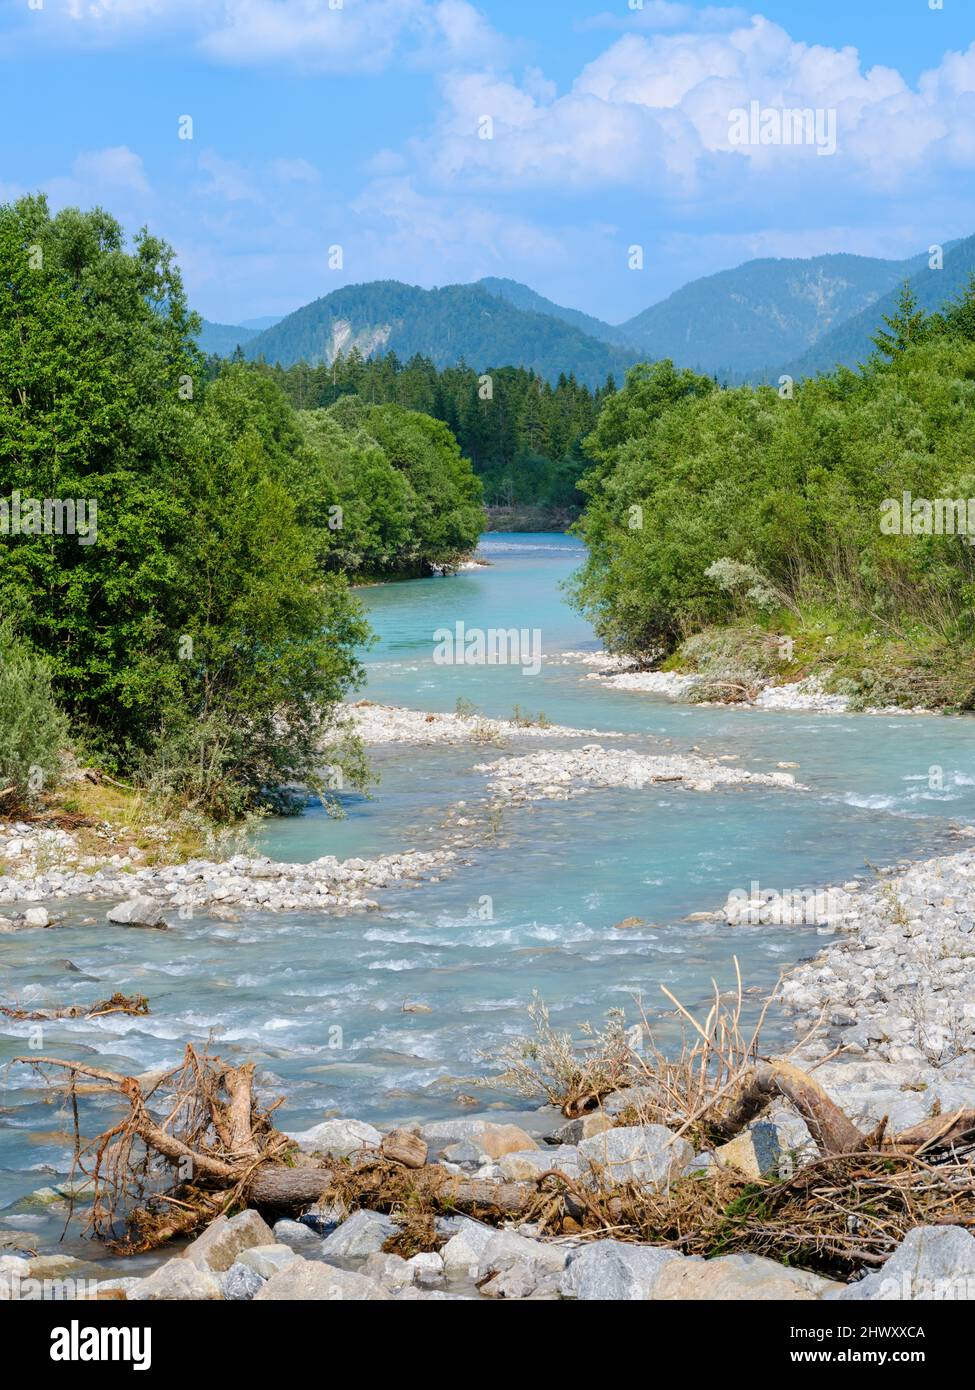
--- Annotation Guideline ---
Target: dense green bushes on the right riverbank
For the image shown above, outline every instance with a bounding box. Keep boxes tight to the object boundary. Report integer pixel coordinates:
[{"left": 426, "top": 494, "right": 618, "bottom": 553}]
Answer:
[{"left": 573, "top": 314, "right": 975, "bottom": 706}]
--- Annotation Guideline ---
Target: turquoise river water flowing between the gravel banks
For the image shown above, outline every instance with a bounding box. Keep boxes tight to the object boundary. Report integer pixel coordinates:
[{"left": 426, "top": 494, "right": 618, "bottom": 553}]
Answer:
[{"left": 0, "top": 535, "right": 975, "bottom": 1262}]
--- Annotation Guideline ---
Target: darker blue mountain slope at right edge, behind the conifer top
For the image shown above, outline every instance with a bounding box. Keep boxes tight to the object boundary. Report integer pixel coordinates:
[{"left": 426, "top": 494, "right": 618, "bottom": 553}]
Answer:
[{"left": 782, "top": 236, "right": 975, "bottom": 378}]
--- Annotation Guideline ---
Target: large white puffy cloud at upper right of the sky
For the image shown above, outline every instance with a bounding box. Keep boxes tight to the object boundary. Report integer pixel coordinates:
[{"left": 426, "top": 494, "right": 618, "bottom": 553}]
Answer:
[{"left": 424, "top": 7, "right": 975, "bottom": 202}]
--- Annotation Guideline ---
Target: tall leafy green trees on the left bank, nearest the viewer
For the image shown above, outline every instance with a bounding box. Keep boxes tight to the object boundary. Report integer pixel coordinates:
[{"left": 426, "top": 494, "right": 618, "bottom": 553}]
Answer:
[{"left": 0, "top": 197, "right": 372, "bottom": 819}]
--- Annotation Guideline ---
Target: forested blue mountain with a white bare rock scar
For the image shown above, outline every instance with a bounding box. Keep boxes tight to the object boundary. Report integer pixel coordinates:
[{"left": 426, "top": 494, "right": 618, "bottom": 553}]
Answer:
[{"left": 243, "top": 281, "right": 640, "bottom": 386}]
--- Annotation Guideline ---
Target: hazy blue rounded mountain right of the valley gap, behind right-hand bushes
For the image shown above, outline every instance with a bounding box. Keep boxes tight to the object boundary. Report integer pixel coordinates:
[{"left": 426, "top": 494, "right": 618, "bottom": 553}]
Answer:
[{"left": 618, "top": 254, "right": 926, "bottom": 378}]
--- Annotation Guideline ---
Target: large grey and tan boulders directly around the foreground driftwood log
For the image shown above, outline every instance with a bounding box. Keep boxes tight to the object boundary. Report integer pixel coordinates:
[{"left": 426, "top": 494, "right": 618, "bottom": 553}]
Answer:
[{"left": 7, "top": 1081, "right": 975, "bottom": 1302}]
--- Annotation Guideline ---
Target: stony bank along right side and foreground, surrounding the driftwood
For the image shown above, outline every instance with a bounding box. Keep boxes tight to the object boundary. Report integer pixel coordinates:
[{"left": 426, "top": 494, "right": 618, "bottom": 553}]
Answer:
[{"left": 7, "top": 822, "right": 975, "bottom": 1302}]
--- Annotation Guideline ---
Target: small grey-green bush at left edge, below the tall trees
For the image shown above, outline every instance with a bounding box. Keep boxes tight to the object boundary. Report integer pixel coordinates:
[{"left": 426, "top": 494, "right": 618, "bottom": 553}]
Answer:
[{"left": 0, "top": 620, "right": 68, "bottom": 808}]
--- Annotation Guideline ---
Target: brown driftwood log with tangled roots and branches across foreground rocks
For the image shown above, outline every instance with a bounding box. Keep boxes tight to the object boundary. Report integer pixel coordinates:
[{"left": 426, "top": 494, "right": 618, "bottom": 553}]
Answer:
[{"left": 17, "top": 978, "right": 975, "bottom": 1275}]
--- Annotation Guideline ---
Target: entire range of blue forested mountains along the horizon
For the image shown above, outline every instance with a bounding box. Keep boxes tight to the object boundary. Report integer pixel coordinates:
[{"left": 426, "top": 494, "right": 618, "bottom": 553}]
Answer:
[{"left": 199, "top": 236, "right": 975, "bottom": 386}]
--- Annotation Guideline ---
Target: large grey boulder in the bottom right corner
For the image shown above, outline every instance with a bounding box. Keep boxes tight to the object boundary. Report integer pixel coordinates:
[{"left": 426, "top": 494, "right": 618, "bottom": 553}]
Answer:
[{"left": 828, "top": 1226, "right": 975, "bottom": 1302}]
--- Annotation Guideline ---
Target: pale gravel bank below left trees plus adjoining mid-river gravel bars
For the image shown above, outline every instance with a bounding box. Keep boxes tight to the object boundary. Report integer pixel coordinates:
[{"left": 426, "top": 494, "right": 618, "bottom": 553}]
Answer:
[{"left": 0, "top": 701, "right": 801, "bottom": 931}]
